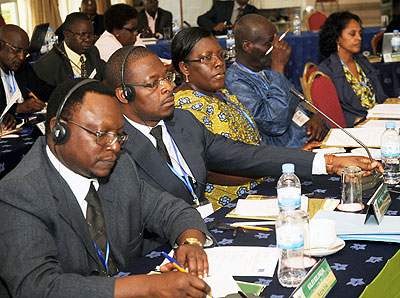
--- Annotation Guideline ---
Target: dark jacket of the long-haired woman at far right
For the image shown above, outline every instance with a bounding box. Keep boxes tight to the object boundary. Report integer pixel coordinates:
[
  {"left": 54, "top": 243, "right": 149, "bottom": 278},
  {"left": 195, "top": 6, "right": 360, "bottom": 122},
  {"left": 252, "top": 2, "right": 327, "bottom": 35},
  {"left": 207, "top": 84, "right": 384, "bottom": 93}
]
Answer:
[{"left": 318, "top": 53, "right": 387, "bottom": 127}]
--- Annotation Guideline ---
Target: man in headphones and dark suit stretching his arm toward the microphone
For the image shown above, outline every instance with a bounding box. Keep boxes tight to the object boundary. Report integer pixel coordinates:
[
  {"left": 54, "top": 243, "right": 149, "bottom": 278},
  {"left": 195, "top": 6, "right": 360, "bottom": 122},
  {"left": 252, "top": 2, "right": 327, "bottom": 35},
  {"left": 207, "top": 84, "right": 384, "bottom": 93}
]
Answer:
[{"left": 106, "top": 47, "right": 383, "bottom": 208}]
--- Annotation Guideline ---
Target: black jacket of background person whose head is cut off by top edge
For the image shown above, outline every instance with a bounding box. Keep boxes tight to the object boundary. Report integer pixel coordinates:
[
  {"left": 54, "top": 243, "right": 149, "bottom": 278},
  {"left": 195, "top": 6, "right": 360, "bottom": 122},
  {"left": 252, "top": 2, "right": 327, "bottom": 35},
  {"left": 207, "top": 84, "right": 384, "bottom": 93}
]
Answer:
[{"left": 197, "top": 1, "right": 259, "bottom": 34}]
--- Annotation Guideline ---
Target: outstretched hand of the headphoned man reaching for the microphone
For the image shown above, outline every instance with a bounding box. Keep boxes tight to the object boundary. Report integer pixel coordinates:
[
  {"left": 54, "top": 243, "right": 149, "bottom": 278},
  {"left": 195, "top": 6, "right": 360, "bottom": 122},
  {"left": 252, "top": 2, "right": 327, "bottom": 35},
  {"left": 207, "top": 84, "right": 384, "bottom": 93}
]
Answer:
[{"left": 325, "top": 156, "right": 383, "bottom": 176}]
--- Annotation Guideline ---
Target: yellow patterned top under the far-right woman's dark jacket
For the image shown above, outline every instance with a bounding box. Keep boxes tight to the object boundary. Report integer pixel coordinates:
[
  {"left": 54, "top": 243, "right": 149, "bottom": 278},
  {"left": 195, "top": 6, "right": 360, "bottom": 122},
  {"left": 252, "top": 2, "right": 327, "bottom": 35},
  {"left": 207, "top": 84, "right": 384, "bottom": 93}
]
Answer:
[{"left": 343, "top": 62, "right": 377, "bottom": 109}]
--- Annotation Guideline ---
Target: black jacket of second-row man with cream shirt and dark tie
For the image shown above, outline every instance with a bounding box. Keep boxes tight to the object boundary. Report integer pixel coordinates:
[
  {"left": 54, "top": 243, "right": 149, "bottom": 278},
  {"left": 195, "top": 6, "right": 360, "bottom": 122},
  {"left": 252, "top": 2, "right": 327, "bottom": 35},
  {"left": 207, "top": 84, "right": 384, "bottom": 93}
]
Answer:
[{"left": 33, "top": 43, "right": 106, "bottom": 86}]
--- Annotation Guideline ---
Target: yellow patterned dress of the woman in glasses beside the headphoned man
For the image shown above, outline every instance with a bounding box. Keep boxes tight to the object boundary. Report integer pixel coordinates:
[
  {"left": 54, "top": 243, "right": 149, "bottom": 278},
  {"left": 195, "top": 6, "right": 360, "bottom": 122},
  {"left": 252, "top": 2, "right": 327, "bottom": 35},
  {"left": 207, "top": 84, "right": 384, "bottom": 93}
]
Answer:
[{"left": 175, "top": 89, "right": 263, "bottom": 210}]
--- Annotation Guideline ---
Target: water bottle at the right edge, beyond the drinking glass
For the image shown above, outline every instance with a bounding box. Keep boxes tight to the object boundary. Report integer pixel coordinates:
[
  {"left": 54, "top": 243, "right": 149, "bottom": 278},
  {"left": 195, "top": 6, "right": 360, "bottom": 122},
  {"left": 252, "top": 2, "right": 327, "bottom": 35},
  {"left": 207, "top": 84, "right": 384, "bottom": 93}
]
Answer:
[{"left": 381, "top": 121, "right": 400, "bottom": 184}]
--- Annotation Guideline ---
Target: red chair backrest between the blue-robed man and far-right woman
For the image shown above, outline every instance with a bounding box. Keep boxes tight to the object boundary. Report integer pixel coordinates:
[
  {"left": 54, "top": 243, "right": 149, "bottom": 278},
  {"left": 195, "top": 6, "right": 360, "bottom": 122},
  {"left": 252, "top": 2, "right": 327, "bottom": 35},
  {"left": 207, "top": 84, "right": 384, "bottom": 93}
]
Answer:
[{"left": 309, "top": 71, "right": 347, "bottom": 128}]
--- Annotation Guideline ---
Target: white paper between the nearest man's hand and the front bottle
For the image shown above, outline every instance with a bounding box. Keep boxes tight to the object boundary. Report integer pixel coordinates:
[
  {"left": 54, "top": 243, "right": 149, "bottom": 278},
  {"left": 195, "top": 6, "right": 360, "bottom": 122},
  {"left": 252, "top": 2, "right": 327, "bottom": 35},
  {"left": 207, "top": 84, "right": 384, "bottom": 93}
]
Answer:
[{"left": 205, "top": 246, "right": 279, "bottom": 277}]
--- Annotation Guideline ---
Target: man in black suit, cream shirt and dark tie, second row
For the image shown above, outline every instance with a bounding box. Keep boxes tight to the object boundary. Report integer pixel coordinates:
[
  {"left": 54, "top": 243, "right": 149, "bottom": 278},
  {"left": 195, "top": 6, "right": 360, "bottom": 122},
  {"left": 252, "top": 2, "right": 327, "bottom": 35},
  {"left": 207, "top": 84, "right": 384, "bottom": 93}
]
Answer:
[{"left": 33, "top": 12, "right": 105, "bottom": 85}]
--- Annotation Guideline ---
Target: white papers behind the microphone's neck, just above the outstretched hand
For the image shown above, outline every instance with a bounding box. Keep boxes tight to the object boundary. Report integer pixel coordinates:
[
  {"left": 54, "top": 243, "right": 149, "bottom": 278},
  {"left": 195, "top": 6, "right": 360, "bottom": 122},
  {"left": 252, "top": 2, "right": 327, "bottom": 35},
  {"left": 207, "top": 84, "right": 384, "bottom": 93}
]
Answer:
[{"left": 324, "top": 127, "right": 385, "bottom": 148}]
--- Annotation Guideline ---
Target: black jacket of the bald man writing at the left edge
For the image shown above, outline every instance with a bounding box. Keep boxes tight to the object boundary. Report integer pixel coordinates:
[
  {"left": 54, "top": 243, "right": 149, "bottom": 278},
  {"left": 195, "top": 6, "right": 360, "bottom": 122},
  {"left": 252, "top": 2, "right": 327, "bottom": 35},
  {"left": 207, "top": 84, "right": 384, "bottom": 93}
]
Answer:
[{"left": 0, "top": 61, "right": 54, "bottom": 114}]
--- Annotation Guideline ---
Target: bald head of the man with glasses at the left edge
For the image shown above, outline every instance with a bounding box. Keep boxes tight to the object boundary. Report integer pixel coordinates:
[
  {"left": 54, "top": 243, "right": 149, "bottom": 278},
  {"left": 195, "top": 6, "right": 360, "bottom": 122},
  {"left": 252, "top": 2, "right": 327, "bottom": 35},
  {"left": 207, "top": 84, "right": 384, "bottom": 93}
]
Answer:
[{"left": 0, "top": 25, "right": 29, "bottom": 73}]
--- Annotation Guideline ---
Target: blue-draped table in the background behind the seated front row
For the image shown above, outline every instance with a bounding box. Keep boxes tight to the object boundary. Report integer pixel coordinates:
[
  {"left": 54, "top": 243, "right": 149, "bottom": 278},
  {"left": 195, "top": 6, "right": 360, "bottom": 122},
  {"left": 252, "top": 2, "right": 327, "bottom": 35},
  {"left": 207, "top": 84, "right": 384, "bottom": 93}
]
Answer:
[{"left": 146, "top": 27, "right": 383, "bottom": 90}]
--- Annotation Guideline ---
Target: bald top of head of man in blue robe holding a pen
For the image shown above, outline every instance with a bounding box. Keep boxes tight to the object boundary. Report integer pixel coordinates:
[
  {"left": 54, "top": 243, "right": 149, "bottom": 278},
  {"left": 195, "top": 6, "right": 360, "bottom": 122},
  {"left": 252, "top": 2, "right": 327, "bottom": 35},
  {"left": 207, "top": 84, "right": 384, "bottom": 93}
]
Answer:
[{"left": 234, "top": 14, "right": 276, "bottom": 51}]
